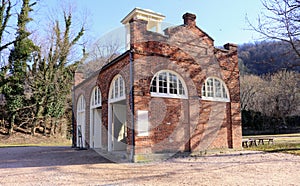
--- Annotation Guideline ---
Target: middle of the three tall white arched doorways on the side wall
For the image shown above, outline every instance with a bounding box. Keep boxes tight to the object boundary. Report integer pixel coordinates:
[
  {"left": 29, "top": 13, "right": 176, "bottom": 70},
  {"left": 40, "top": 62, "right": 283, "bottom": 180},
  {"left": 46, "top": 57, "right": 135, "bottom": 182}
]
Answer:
[{"left": 90, "top": 86, "right": 102, "bottom": 148}]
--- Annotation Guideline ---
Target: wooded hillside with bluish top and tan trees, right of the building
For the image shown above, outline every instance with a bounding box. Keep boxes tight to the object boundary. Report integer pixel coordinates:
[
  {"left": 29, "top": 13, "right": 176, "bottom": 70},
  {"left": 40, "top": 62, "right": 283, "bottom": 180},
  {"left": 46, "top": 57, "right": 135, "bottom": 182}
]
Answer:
[{"left": 239, "top": 41, "right": 300, "bottom": 134}]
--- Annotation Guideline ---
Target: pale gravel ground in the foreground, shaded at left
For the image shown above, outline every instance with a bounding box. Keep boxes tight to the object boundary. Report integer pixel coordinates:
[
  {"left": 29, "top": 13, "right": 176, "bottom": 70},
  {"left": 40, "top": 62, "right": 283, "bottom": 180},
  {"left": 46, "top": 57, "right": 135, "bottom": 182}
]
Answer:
[{"left": 0, "top": 147, "right": 300, "bottom": 185}]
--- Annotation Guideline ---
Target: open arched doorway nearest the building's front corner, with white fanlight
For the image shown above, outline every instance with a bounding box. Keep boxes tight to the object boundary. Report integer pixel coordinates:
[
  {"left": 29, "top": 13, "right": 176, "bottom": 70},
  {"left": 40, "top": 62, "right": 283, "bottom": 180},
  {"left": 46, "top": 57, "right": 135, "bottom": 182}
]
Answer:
[{"left": 108, "top": 75, "right": 127, "bottom": 151}]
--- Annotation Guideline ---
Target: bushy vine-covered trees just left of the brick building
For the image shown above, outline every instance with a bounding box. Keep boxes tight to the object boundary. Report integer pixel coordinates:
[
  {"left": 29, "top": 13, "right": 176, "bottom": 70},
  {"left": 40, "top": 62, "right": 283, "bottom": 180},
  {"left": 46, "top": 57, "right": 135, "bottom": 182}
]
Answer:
[{"left": 29, "top": 13, "right": 85, "bottom": 135}]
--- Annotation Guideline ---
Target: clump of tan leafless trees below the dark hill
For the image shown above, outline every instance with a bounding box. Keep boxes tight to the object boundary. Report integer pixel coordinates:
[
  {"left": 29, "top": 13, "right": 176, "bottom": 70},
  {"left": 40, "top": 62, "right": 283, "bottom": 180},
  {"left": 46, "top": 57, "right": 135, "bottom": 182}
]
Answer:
[{"left": 240, "top": 70, "right": 300, "bottom": 129}]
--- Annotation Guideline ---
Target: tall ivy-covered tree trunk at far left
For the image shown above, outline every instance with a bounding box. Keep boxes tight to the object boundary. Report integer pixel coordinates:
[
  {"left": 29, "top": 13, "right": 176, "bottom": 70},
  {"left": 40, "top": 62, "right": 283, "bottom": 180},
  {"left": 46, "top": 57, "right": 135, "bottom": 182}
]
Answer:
[{"left": 3, "top": 0, "right": 37, "bottom": 134}]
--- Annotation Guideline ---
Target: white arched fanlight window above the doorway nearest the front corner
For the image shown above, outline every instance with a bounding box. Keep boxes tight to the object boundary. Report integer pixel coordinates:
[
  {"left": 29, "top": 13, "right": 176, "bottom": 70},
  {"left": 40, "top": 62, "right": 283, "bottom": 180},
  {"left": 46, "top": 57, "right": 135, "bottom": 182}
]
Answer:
[{"left": 109, "top": 75, "right": 126, "bottom": 102}]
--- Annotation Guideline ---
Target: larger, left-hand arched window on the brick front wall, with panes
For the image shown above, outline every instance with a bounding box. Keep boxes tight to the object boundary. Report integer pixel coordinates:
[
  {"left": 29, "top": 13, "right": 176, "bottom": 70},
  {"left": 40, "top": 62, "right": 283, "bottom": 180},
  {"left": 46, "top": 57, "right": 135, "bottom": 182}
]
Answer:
[{"left": 150, "top": 70, "right": 187, "bottom": 99}]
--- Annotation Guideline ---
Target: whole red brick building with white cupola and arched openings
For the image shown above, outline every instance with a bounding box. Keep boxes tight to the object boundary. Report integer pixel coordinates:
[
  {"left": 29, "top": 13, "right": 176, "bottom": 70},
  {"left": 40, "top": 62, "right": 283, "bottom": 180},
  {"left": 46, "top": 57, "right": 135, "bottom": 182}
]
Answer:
[{"left": 73, "top": 8, "right": 242, "bottom": 161}]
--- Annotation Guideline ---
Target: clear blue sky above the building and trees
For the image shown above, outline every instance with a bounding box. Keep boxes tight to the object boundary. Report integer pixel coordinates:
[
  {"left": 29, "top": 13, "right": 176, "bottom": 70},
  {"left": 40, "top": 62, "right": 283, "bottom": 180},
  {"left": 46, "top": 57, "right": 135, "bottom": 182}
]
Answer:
[{"left": 39, "top": 0, "right": 263, "bottom": 46}]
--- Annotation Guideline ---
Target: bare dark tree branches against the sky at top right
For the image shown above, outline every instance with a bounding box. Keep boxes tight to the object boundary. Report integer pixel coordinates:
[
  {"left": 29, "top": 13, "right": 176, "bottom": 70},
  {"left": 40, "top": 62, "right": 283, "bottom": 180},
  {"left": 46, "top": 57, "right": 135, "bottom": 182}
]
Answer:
[{"left": 248, "top": 0, "right": 300, "bottom": 66}]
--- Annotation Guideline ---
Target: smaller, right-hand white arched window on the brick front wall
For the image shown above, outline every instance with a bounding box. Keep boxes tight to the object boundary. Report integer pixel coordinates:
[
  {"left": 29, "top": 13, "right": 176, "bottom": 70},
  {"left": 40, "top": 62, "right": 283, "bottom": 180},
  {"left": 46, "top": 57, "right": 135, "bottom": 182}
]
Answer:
[{"left": 202, "top": 77, "right": 230, "bottom": 102}]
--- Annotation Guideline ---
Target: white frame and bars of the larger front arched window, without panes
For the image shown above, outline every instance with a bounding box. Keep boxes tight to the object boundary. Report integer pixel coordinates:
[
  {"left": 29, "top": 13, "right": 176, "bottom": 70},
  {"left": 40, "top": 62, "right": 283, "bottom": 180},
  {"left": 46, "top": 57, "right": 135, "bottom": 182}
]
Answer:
[{"left": 150, "top": 70, "right": 188, "bottom": 99}]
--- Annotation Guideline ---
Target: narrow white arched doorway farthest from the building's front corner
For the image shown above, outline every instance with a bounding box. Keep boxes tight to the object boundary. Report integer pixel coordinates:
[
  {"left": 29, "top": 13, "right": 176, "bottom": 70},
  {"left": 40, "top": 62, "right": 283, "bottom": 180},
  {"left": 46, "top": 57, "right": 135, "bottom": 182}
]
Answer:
[{"left": 76, "top": 95, "right": 86, "bottom": 148}]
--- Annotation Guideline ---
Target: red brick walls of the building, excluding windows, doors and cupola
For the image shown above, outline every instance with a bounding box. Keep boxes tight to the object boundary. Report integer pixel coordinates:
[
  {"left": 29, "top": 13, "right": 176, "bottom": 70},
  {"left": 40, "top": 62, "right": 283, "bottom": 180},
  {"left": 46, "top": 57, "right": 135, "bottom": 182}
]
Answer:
[{"left": 75, "top": 12, "right": 241, "bottom": 157}]
